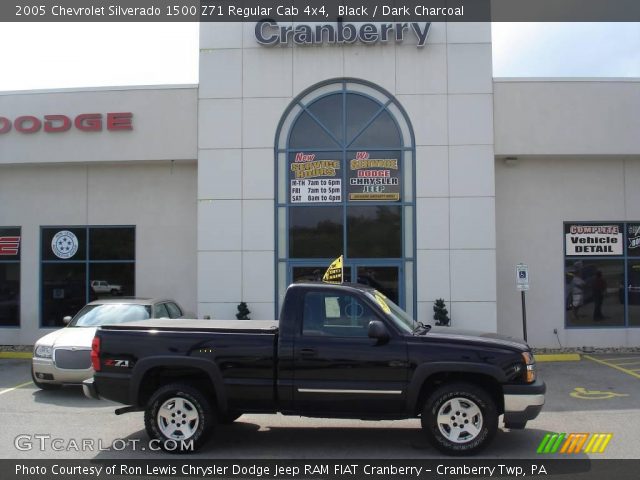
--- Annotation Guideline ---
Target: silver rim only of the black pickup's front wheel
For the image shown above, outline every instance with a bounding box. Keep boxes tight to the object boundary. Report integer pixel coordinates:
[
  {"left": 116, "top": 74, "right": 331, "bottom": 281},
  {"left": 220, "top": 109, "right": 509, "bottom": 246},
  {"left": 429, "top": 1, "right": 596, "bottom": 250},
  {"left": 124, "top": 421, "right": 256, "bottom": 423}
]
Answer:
[{"left": 436, "top": 397, "right": 483, "bottom": 443}]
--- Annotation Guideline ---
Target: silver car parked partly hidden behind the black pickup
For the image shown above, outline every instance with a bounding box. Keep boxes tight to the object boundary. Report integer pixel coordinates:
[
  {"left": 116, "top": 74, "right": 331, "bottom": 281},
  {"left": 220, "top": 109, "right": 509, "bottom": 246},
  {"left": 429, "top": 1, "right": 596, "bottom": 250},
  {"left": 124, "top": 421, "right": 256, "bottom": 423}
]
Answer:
[{"left": 31, "top": 298, "right": 186, "bottom": 390}]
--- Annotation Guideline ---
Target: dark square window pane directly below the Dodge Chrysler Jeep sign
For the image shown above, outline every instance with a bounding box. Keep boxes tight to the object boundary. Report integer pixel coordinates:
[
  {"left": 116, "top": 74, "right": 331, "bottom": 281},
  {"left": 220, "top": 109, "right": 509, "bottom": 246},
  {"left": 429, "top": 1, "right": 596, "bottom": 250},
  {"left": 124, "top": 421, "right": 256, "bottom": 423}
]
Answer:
[{"left": 347, "top": 206, "right": 402, "bottom": 258}]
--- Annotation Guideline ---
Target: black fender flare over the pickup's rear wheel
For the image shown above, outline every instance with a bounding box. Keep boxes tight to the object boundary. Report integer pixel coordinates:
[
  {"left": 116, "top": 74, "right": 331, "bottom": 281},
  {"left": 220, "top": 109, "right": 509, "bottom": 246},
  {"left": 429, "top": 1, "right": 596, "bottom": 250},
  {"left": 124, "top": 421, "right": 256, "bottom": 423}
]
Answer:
[{"left": 129, "top": 355, "right": 227, "bottom": 412}]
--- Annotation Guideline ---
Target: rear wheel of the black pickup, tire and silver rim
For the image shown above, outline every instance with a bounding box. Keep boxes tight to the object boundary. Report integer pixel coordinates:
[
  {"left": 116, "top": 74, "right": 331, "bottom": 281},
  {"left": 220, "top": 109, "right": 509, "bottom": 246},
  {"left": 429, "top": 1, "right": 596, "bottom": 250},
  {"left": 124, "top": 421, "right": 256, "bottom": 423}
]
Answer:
[{"left": 144, "top": 383, "right": 216, "bottom": 453}]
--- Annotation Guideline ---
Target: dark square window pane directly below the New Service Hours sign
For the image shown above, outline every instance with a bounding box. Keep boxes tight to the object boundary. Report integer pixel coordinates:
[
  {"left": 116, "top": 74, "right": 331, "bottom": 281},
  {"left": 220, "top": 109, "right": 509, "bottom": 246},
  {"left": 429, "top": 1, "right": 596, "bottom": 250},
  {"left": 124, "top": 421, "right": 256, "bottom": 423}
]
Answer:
[{"left": 289, "top": 207, "right": 343, "bottom": 258}]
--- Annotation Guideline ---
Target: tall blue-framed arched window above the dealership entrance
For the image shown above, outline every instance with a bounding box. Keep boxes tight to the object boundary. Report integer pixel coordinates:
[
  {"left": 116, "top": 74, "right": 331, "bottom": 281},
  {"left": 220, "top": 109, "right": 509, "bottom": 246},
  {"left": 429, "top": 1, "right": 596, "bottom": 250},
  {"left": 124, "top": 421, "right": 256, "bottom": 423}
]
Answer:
[{"left": 275, "top": 79, "right": 416, "bottom": 313}]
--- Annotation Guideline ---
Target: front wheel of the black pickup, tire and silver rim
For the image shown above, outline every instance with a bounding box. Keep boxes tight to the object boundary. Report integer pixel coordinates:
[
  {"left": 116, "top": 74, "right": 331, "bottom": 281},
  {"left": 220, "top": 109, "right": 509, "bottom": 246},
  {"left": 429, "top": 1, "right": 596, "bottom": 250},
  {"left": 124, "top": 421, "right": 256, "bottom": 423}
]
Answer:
[{"left": 421, "top": 383, "right": 498, "bottom": 456}]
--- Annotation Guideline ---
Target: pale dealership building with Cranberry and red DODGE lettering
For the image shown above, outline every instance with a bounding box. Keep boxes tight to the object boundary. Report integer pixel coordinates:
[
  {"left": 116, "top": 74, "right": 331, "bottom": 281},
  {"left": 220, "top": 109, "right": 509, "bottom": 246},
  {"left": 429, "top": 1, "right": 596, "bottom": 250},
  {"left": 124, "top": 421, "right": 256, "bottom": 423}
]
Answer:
[{"left": 0, "top": 22, "right": 640, "bottom": 347}]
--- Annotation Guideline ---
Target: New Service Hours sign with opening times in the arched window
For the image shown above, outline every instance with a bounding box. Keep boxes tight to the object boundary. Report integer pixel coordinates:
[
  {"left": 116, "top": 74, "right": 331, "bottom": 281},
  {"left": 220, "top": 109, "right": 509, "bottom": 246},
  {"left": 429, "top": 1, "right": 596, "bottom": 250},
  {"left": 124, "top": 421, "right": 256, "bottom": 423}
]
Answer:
[{"left": 290, "top": 152, "right": 342, "bottom": 203}]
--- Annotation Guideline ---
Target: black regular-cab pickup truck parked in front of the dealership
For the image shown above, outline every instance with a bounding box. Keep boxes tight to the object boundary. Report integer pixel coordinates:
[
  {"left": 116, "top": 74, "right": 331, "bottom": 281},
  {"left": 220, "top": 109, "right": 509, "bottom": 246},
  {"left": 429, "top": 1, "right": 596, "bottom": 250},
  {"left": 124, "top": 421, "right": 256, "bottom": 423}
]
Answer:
[{"left": 83, "top": 283, "right": 545, "bottom": 455}]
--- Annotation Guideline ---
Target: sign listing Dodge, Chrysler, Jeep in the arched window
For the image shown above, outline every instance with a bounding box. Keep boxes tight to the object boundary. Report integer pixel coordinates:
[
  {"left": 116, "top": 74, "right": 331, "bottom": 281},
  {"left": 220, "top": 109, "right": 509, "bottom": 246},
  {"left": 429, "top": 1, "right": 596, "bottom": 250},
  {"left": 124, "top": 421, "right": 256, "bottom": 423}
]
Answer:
[{"left": 349, "top": 152, "right": 400, "bottom": 202}]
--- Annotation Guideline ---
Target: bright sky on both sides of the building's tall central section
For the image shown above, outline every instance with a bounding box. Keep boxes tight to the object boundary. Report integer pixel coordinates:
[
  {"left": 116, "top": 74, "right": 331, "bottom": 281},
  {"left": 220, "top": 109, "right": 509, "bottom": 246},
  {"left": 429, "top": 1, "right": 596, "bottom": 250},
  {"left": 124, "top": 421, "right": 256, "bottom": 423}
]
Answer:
[{"left": 0, "top": 23, "right": 640, "bottom": 91}]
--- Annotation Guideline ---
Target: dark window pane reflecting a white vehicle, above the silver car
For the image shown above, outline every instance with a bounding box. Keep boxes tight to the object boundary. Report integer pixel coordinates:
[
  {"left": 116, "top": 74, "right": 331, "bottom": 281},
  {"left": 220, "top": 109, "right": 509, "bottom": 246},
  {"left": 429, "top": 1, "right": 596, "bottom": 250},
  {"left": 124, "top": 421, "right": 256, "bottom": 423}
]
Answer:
[{"left": 89, "top": 263, "right": 135, "bottom": 302}]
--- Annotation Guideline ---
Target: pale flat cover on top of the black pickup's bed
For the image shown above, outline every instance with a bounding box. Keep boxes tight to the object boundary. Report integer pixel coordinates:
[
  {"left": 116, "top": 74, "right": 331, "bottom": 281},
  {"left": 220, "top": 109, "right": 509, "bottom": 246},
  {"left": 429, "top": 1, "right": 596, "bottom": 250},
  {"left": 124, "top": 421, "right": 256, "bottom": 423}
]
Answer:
[{"left": 101, "top": 318, "right": 278, "bottom": 334}]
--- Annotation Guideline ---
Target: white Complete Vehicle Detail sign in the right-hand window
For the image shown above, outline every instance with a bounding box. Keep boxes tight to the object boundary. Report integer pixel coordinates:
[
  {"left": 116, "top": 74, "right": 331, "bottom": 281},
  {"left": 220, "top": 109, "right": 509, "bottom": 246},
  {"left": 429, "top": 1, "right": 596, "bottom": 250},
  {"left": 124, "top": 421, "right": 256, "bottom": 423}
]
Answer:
[{"left": 565, "top": 224, "right": 623, "bottom": 256}]
